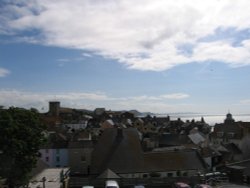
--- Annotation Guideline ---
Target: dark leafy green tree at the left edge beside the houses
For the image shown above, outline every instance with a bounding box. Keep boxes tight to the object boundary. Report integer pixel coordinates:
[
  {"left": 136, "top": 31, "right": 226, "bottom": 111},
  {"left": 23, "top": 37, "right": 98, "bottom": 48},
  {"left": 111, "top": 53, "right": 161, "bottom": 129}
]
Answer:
[{"left": 0, "top": 107, "right": 45, "bottom": 187}]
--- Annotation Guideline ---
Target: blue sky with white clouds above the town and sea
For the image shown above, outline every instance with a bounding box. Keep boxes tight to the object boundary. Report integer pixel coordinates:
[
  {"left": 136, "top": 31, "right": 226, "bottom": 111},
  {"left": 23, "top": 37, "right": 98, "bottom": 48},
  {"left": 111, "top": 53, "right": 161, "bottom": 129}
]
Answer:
[{"left": 0, "top": 0, "right": 250, "bottom": 114}]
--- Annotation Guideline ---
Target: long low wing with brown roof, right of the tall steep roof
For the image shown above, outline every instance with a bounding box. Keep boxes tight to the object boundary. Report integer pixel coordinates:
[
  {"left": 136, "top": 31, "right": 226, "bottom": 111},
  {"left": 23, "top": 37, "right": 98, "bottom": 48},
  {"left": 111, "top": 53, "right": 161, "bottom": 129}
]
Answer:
[{"left": 142, "top": 150, "right": 207, "bottom": 178}]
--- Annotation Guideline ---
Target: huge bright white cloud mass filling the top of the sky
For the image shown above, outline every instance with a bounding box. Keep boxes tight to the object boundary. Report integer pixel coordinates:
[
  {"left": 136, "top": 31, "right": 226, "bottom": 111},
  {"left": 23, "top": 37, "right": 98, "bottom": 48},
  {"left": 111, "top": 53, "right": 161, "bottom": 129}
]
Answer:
[{"left": 0, "top": 0, "right": 250, "bottom": 71}]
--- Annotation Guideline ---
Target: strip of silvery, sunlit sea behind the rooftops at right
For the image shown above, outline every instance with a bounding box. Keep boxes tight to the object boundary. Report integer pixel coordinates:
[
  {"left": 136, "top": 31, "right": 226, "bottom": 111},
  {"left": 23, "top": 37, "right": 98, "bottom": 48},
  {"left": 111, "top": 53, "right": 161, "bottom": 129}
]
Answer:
[{"left": 156, "top": 113, "right": 250, "bottom": 126}]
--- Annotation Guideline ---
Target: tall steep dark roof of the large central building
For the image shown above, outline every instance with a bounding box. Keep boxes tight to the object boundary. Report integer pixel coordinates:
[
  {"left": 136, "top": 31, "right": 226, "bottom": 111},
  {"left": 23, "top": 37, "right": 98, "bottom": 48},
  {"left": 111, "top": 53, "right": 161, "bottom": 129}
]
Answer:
[{"left": 91, "top": 128, "right": 143, "bottom": 174}]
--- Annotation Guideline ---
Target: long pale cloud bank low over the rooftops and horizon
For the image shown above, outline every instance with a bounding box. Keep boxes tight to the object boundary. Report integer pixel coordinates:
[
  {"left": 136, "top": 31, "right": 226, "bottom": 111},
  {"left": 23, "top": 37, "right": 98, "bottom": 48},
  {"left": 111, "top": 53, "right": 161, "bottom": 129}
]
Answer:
[{"left": 0, "top": 89, "right": 190, "bottom": 113}]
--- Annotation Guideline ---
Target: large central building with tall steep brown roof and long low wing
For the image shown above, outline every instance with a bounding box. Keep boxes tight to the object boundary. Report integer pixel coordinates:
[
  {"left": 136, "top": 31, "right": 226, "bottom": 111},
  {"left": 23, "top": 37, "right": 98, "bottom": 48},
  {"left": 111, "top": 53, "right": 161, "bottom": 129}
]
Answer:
[{"left": 90, "top": 128, "right": 206, "bottom": 178}]
